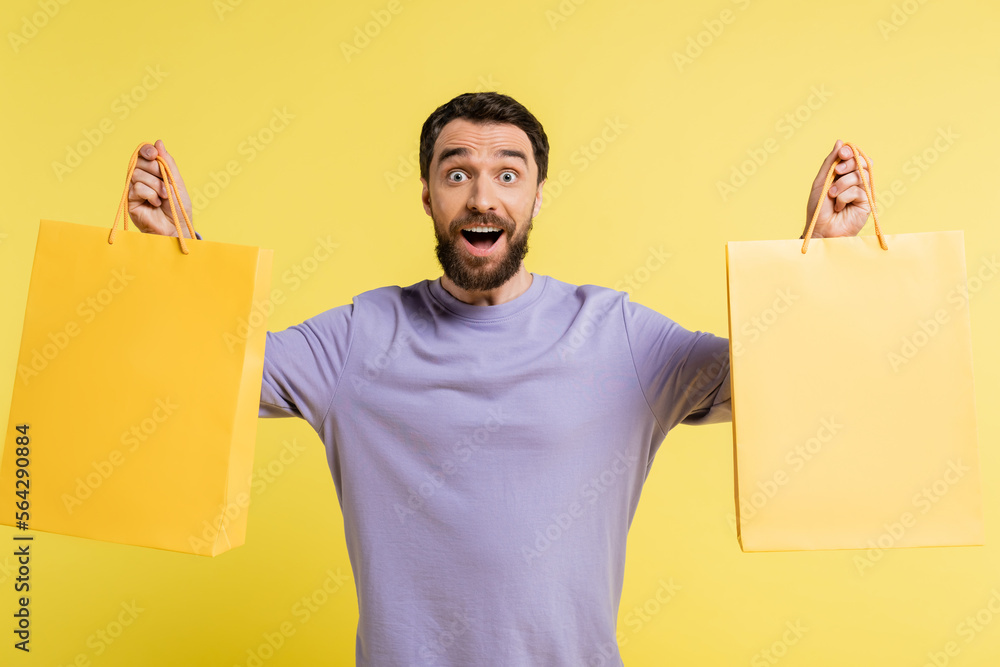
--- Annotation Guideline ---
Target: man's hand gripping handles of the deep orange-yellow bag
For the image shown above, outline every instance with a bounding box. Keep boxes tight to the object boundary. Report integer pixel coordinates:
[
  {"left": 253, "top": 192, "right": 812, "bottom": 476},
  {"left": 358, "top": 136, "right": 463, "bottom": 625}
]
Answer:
[{"left": 128, "top": 140, "right": 194, "bottom": 238}]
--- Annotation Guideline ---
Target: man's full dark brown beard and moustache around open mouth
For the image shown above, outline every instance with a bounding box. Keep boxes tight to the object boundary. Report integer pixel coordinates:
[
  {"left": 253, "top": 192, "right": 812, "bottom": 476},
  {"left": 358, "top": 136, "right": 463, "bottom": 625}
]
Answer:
[{"left": 432, "top": 213, "right": 532, "bottom": 292}]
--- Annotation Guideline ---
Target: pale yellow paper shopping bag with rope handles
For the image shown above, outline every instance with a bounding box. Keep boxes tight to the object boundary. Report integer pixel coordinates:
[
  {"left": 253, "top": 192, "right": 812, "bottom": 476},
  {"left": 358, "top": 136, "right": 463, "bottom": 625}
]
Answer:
[{"left": 726, "top": 144, "right": 983, "bottom": 553}]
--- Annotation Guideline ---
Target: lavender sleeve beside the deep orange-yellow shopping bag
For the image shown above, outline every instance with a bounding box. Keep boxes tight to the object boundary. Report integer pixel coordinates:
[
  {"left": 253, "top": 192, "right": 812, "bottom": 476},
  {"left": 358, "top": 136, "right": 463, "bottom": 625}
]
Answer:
[{"left": 258, "top": 305, "right": 354, "bottom": 432}]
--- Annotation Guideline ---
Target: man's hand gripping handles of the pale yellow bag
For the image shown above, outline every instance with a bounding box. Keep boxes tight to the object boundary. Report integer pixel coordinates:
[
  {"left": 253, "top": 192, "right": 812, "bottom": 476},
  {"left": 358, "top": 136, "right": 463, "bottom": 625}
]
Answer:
[{"left": 802, "top": 139, "right": 871, "bottom": 239}]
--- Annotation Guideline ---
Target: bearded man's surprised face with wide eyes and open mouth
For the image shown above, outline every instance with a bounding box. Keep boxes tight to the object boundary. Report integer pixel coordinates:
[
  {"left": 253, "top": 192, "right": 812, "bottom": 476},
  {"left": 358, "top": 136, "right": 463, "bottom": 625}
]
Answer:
[{"left": 420, "top": 118, "right": 542, "bottom": 291}]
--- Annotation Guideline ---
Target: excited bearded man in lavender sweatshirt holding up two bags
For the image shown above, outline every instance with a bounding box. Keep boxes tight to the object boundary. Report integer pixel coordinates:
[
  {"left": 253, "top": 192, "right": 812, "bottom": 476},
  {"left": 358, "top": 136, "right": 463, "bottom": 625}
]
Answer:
[{"left": 129, "top": 93, "right": 868, "bottom": 667}]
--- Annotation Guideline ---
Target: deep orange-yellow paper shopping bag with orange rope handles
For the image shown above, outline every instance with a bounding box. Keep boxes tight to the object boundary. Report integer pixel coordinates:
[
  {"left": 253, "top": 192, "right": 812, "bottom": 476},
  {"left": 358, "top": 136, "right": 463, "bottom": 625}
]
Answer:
[{"left": 0, "top": 148, "right": 272, "bottom": 556}]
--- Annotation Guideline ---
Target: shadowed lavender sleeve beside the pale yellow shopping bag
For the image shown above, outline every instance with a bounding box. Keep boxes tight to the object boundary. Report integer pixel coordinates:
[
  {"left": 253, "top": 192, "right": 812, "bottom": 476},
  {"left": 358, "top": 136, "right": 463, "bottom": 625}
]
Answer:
[{"left": 623, "top": 298, "right": 732, "bottom": 434}]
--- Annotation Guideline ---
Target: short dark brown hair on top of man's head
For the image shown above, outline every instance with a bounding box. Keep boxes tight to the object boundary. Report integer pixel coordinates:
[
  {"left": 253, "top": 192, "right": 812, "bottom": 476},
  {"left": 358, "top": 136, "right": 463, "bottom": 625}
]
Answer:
[{"left": 420, "top": 92, "right": 549, "bottom": 183}]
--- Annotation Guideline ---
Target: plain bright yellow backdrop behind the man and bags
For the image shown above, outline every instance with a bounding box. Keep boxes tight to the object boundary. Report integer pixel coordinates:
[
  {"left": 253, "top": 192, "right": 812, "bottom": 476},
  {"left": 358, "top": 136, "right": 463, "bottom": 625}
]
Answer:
[{"left": 0, "top": 0, "right": 1000, "bottom": 667}]
